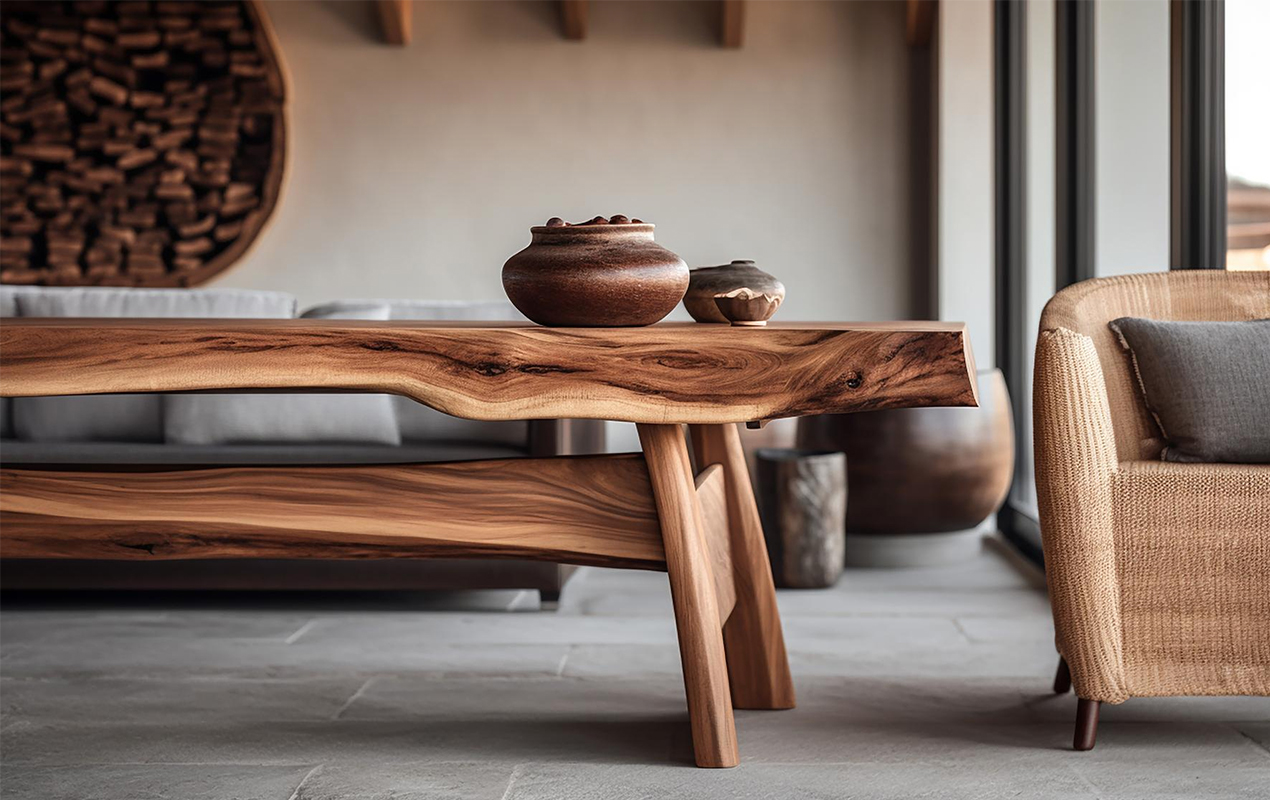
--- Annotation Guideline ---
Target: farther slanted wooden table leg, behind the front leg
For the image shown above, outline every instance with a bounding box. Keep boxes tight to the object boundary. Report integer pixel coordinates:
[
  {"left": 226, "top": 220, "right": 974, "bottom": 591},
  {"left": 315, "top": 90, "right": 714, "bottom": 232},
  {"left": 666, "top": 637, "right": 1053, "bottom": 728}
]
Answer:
[{"left": 690, "top": 424, "right": 794, "bottom": 709}]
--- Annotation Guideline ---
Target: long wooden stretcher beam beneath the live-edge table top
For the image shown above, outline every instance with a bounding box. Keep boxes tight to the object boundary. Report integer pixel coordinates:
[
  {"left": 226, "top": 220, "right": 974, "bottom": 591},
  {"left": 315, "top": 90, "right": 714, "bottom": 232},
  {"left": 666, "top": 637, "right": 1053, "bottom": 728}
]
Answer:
[{"left": 0, "top": 456, "right": 665, "bottom": 569}]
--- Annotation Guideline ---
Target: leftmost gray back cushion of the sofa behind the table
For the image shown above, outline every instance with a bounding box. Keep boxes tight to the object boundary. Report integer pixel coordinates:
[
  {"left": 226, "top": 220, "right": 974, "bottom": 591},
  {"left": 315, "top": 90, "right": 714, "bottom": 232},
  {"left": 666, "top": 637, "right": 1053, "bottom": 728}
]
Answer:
[{"left": 13, "top": 288, "right": 296, "bottom": 442}]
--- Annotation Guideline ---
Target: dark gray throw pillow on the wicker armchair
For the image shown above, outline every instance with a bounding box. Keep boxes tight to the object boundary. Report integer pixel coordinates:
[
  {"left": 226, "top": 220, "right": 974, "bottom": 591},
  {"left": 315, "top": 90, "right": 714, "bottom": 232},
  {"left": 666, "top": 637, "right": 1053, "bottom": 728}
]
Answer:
[{"left": 1110, "top": 317, "right": 1270, "bottom": 463}]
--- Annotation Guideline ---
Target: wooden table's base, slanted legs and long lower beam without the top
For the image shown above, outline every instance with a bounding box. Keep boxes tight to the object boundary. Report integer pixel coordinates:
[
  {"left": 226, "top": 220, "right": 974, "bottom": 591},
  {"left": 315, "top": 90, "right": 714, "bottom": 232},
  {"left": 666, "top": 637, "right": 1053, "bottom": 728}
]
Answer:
[{"left": 0, "top": 424, "right": 794, "bottom": 767}]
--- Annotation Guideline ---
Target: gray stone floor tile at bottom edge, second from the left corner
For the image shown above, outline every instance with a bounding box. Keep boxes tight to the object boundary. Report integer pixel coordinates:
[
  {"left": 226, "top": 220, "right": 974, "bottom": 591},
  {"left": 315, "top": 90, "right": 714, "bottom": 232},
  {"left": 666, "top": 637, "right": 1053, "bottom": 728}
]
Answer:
[{"left": 295, "top": 762, "right": 514, "bottom": 800}]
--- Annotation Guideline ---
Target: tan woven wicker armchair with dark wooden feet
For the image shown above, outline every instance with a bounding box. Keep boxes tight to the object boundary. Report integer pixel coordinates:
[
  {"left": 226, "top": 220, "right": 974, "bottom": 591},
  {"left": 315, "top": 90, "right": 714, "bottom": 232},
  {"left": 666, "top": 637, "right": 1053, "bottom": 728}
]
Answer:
[{"left": 1033, "top": 270, "right": 1270, "bottom": 750}]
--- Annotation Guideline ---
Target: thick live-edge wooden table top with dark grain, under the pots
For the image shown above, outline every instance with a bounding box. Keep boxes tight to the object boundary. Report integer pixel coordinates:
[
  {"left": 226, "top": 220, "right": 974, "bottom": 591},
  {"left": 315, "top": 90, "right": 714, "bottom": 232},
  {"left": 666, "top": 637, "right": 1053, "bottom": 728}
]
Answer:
[{"left": 0, "top": 317, "right": 978, "bottom": 424}]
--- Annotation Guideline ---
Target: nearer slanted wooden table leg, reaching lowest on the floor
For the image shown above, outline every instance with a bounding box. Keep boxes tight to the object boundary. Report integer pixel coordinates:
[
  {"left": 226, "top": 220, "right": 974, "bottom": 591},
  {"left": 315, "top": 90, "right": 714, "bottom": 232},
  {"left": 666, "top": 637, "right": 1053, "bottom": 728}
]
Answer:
[{"left": 639, "top": 424, "right": 740, "bottom": 767}]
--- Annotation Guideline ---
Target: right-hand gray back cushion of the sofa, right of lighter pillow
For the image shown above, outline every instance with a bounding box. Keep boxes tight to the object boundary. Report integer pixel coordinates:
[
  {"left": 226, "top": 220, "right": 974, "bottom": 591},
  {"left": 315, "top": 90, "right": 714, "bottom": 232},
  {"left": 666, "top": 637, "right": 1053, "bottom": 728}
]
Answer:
[{"left": 301, "top": 300, "right": 530, "bottom": 448}]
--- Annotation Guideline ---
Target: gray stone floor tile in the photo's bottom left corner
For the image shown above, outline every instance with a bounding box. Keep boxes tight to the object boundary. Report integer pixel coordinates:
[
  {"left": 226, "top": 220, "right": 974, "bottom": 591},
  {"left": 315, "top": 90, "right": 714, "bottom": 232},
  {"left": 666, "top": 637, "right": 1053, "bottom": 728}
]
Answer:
[{"left": 3, "top": 764, "right": 314, "bottom": 800}]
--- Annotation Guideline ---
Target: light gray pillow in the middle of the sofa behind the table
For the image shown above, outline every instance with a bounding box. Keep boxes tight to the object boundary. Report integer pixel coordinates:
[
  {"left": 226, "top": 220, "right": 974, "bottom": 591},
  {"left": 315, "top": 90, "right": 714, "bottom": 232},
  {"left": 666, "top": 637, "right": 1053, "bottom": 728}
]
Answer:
[{"left": 164, "top": 303, "right": 401, "bottom": 444}]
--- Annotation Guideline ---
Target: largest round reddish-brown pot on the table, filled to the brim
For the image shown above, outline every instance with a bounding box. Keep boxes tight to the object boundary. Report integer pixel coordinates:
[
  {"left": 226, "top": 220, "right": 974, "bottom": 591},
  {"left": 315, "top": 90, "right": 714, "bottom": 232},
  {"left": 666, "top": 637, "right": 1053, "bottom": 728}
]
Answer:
[{"left": 503, "top": 217, "right": 688, "bottom": 328}]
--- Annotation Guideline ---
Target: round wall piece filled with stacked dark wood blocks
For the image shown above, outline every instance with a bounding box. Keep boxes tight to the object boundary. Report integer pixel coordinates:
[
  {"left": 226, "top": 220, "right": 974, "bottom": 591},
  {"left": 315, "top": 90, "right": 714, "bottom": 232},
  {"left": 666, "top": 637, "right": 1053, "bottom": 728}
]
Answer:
[{"left": 0, "top": 0, "right": 286, "bottom": 286}]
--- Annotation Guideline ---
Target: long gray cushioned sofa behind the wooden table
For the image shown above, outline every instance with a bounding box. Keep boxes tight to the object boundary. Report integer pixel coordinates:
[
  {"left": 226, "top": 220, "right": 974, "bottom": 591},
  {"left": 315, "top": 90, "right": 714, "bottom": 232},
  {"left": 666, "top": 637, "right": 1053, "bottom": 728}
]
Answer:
[{"left": 0, "top": 286, "right": 605, "bottom": 602}]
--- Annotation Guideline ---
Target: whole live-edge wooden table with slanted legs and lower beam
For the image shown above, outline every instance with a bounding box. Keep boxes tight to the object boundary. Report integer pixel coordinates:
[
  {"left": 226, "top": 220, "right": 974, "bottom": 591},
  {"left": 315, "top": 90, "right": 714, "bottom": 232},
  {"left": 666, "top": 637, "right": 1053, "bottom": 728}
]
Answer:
[{"left": 0, "top": 319, "right": 977, "bottom": 767}]
